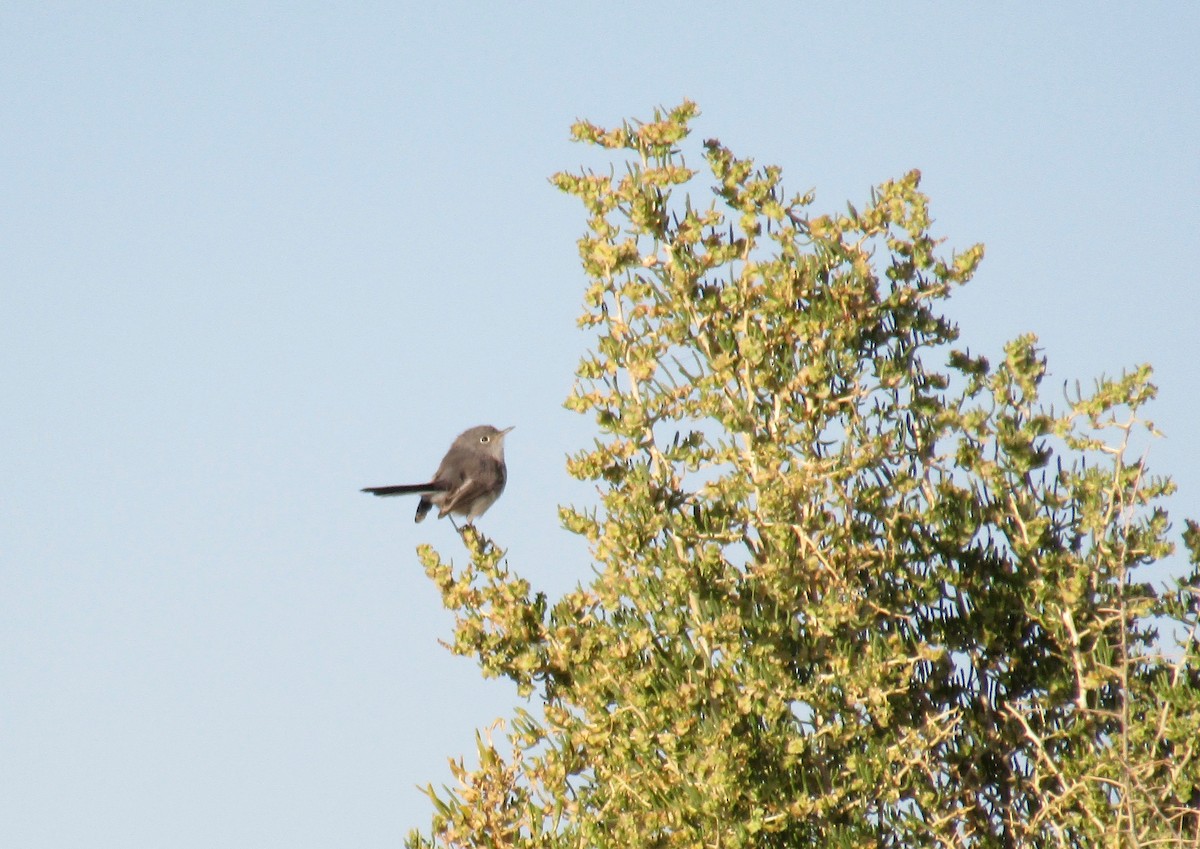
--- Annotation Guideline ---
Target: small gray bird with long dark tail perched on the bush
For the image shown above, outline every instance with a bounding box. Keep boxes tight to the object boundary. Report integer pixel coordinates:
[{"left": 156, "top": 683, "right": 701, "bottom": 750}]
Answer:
[{"left": 362, "top": 425, "right": 512, "bottom": 530}]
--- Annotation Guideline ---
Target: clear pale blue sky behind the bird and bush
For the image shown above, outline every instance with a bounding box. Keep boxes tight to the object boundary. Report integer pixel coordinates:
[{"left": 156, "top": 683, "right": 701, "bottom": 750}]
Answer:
[{"left": 0, "top": 1, "right": 1200, "bottom": 849}]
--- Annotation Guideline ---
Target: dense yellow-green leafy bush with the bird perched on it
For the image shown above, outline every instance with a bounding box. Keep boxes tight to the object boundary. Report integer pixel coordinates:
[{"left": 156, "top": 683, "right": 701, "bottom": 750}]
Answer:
[{"left": 409, "top": 103, "right": 1200, "bottom": 848}]
